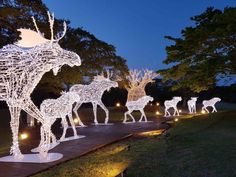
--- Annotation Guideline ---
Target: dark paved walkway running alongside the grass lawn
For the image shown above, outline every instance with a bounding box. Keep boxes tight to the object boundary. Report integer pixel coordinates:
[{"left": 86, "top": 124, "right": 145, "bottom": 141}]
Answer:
[{"left": 0, "top": 119, "right": 167, "bottom": 177}]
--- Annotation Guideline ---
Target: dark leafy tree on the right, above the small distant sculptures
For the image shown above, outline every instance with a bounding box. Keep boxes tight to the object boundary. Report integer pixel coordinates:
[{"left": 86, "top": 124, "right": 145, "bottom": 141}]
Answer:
[{"left": 160, "top": 7, "right": 236, "bottom": 92}]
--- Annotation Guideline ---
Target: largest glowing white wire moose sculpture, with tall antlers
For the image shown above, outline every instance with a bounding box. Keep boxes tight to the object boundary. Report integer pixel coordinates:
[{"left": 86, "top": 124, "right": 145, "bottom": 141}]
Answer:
[{"left": 0, "top": 12, "right": 81, "bottom": 161}]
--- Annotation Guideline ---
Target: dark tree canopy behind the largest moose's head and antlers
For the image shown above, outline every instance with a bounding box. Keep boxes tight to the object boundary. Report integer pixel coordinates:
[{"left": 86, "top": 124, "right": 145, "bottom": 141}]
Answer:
[{"left": 0, "top": 0, "right": 128, "bottom": 93}]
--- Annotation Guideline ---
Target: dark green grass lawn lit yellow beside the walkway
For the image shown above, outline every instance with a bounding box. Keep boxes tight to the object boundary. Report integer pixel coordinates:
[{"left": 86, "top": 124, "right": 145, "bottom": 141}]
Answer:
[{"left": 31, "top": 111, "right": 236, "bottom": 177}]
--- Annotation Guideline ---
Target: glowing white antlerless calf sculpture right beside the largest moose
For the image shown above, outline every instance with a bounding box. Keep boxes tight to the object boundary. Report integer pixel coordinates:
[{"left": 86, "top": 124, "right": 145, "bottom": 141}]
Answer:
[{"left": 40, "top": 92, "right": 80, "bottom": 147}]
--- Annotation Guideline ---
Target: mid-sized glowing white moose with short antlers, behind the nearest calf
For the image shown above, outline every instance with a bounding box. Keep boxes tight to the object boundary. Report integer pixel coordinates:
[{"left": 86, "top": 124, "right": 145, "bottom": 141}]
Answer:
[{"left": 70, "top": 71, "right": 118, "bottom": 126}]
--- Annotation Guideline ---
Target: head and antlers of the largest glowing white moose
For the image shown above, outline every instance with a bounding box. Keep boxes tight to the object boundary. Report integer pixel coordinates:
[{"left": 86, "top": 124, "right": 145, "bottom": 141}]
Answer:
[{"left": 16, "top": 12, "right": 81, "bottom": 75}]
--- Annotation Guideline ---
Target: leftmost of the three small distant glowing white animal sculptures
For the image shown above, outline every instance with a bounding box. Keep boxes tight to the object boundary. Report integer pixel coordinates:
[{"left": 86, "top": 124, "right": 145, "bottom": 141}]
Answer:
[{"left": 164, "top": 96, "right": 182, "bottom": 117}]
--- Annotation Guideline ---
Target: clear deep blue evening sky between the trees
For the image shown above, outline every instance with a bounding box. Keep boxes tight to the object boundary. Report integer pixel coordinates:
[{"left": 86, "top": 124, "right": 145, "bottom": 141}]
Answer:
[{"left": 43, "top": 0, "right": 236, "bottom": 70}]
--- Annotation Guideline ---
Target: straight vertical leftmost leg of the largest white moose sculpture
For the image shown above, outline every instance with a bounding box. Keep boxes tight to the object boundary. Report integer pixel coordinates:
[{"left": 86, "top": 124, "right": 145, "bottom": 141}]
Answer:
[{"left": 9, "top": 106, "right": 24, "bottom": 159}]
